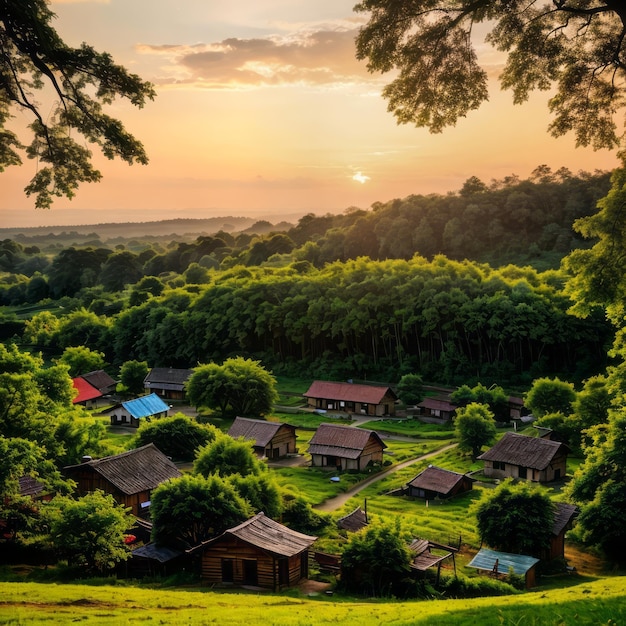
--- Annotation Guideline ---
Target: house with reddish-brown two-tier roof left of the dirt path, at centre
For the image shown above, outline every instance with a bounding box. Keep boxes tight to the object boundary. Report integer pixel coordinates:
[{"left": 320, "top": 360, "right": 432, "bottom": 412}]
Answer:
[{"left": 309, "top": 424, "right": 387, "bottom": 471}]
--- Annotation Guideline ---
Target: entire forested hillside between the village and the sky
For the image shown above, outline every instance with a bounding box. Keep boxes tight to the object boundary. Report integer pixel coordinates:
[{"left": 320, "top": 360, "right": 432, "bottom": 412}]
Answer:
[{"left": 0, "top": 167, "right": 612, "bottom": 387}]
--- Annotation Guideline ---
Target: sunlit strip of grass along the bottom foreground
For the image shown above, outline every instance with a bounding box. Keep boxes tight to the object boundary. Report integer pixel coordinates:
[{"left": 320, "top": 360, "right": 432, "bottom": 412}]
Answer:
[{"left": 0, "top": 577, "right": 626, "bottom": 626}]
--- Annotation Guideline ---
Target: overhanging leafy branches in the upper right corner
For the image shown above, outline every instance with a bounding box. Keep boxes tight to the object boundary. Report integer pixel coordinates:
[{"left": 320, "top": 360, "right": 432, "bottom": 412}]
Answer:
[{"left": 354, "top": 0, "right": 626, "bottom": 148}]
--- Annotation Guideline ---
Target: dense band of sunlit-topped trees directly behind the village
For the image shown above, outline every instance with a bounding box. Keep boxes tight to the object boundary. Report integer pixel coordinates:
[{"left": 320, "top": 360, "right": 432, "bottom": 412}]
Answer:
[{"left": 23, "top": 256, "right": 611, "bottom": 384}]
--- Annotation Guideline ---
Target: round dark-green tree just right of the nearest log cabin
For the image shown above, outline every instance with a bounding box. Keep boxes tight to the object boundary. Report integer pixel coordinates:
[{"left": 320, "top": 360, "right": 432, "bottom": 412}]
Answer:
[{"left": 341, "top": 525, "right": 411, "bottom": 597}]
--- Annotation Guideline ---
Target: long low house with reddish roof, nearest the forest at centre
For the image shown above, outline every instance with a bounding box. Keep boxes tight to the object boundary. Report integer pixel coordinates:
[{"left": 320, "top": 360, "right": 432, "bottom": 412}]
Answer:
[{"left": 303, "top": 380, "right": 398, "bottom": 417}]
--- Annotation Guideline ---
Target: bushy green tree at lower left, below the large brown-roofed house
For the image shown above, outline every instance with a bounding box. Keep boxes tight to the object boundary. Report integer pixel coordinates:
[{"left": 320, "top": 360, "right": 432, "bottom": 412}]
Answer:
[{"left": 46, "top": 491, "right": 135, "bottom": 572}]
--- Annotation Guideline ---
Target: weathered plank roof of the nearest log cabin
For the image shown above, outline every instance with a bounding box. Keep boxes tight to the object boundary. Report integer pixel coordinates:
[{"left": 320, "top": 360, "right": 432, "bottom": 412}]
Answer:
[{"left": 202, "top": 513, "right": 317, "bottom": 556}]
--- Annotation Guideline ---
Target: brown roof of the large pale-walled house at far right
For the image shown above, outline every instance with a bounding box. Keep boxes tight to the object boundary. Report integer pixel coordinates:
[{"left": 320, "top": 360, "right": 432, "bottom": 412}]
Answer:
[{"left": 477, "top": 432, "right": 569, "bottom": 470}]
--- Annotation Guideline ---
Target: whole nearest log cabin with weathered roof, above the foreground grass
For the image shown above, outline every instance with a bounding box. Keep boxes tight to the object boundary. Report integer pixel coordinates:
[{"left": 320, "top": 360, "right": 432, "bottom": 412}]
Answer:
[{"left": 194, "top": 513, "right": 317, "bottom": 591}]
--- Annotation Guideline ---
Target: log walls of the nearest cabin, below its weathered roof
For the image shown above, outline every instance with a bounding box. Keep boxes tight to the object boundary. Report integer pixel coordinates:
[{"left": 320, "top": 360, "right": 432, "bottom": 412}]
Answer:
[{"left": 202, "top": 536, "right": 308, "bottom": 591}]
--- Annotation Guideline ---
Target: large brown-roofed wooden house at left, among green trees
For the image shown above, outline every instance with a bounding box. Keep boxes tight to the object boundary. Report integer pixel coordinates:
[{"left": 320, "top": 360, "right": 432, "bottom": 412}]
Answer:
[{"left": 64, "top": 443, "right": 182, "bottom": 517}]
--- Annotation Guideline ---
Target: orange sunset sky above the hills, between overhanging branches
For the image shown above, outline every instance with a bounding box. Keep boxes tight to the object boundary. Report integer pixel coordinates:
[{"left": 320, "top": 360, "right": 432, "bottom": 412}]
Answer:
[{"left": 0, "top": 0, "right": 617, "bottom": 227}]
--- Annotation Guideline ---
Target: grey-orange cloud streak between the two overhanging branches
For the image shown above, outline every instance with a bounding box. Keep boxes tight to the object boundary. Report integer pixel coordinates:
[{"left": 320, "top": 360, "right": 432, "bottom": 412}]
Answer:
[{"left": 137, "top": 28, "right": 379, "bottom": 89}]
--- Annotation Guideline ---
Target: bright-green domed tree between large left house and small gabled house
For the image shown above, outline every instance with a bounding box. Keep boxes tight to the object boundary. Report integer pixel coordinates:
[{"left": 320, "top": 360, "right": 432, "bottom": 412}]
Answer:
[{"left": 193, "top": 434, "right": 267, "bottom": 476}]
